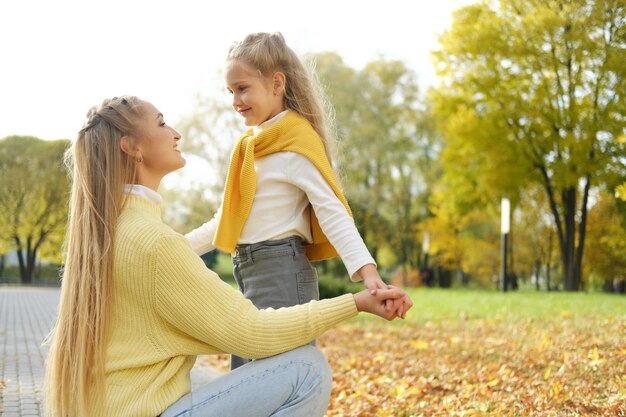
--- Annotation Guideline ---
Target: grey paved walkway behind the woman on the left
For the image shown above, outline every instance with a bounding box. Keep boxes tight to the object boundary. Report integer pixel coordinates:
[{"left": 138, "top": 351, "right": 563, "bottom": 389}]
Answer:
[{"left": 0, "top": 286, "right": 219, "bottom": 417}]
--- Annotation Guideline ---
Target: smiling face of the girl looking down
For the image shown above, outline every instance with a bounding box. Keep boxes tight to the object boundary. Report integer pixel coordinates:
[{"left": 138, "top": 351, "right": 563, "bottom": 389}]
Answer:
[{"left": 225, "top": 60, "right": 285, "bottom": 126}]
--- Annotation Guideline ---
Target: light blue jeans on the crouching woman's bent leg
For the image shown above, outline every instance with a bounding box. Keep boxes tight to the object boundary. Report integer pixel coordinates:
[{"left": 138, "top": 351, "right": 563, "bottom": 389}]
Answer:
[{"left": 161, "top": 345, "right": 332, "bottom": 417}]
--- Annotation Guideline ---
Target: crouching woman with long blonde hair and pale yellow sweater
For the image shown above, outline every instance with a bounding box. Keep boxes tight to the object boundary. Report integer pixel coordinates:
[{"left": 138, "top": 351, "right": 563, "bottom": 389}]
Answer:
[{"left": 45, "top": 96, "right": 412, "bottom": 417}]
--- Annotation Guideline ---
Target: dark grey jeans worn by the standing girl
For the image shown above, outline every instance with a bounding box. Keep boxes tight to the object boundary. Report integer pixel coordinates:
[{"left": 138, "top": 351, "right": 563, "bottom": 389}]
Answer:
[{"left": 230, "top": 236, "right": 319, "bottom": 369}]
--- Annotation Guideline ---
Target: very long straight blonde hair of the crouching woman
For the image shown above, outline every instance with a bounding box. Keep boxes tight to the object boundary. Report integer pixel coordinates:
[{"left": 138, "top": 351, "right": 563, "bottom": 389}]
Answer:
[{"left": 45, "top": 96, "right": 143, "bottom": 417}]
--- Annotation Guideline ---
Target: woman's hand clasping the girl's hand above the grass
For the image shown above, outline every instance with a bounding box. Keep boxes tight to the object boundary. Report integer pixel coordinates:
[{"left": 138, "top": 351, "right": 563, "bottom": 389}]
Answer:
[{"left": 354, "top": 285, "right": 413, "bottom": 320}]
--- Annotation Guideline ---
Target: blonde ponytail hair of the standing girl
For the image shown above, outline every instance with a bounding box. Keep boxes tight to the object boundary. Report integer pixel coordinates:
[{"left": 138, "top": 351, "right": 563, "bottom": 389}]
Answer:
[{"left": 227, "top": 32, "right": 336, "bottom": 164}]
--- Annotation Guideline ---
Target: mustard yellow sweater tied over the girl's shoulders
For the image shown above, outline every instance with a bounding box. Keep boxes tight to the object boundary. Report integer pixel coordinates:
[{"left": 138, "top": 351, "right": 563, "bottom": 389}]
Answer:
[{"left": 213, "top": 111, "right": 352, "bottom": 261}]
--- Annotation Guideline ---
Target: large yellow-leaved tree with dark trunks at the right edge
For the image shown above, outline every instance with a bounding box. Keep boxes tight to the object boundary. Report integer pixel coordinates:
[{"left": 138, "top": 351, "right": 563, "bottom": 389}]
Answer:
[{"left": 431, "top": 0, "right": 626, "bottom": 291}]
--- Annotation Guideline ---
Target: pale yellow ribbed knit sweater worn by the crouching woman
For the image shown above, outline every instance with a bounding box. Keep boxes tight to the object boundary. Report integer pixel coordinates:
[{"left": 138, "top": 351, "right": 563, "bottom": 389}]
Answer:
[{"left": 89, "top": 196, "right": 357, "bottom": 417}]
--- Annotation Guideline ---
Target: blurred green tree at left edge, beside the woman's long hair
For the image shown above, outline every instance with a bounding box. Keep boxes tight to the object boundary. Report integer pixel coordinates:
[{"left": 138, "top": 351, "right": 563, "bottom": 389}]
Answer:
[{"left": 0, "top": 136, "right": 69, "bottom": 283}]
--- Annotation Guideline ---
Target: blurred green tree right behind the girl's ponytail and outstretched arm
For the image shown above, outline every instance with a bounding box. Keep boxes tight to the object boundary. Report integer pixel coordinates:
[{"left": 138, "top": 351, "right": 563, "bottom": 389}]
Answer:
[{"left": 314, "top": 53, "right": 438, "bottom": 276}]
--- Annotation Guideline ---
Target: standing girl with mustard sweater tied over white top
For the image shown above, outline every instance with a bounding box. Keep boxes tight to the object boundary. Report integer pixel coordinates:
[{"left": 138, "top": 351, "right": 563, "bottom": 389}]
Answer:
[{"left": 185, "top": 33, "right": 387, "bottom": 369}]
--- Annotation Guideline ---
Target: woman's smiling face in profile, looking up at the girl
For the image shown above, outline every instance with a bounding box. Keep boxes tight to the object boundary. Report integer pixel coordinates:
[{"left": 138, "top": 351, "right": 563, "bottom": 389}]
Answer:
[{"left": 137, "top": 102, "right": 186, "bottom": 177}]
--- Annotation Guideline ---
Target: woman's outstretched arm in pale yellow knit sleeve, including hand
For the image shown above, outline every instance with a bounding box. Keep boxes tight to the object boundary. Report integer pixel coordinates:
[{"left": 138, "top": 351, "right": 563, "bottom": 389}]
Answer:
[{"left": 149, "top": 235, "right": 406, "bottom": 358}]
